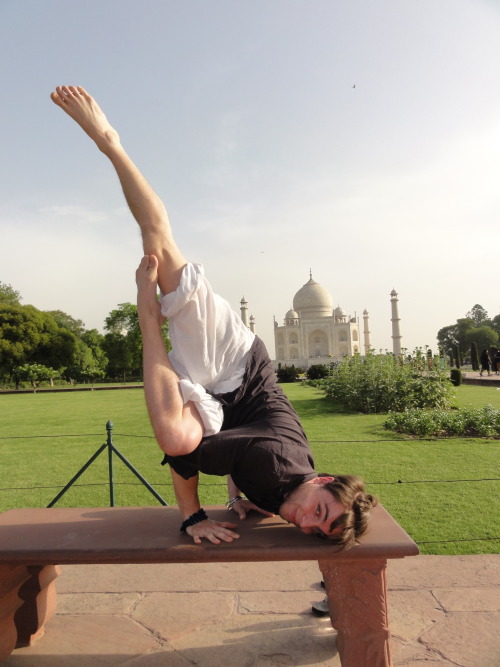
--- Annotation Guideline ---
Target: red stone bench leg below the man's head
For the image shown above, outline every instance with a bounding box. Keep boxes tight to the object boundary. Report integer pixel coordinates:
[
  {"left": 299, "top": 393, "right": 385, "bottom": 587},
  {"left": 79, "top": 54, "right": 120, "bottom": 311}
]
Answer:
[{"left": 319, "top": 559, "right": 392, "bottom": 667}]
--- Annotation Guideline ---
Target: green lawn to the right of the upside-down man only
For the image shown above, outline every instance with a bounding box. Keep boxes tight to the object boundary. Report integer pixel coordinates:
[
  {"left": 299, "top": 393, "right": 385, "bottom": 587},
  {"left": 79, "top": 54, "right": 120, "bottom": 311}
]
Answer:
[{"left": 284, "top": 385, "right": 500, "bottom": 554}]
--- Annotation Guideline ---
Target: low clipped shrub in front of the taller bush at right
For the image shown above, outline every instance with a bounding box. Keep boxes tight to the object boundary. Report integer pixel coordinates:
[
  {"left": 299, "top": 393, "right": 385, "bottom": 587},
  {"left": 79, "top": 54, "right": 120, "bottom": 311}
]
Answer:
[{"left": 383, "top": 405, "right": 500, "bottom": 438}]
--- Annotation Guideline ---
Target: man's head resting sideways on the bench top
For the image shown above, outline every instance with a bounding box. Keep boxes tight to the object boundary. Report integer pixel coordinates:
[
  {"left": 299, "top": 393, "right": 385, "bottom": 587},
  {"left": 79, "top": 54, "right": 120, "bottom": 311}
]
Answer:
[{"left": 279, "top": 473, "right": 377, "bottom": 549}]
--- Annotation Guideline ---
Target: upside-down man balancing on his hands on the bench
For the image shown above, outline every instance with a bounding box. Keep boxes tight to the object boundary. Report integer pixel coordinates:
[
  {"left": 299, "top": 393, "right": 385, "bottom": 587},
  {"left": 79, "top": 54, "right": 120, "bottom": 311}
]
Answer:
[{"left": 51, "top": 86, "right": 376, "bottom": 547}]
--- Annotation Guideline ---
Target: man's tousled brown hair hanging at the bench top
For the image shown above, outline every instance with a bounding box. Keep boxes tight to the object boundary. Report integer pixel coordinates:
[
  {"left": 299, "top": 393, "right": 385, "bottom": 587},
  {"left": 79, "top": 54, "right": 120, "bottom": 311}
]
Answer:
[{"left": 318, "top": 473, "right": 378, "bottom": 549}]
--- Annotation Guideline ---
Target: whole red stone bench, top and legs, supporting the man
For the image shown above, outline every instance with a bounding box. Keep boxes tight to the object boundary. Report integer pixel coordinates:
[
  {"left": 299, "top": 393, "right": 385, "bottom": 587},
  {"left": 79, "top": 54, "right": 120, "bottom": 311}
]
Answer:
[{"left": 0, "top": 505, "right": 418, "bottom": 667}]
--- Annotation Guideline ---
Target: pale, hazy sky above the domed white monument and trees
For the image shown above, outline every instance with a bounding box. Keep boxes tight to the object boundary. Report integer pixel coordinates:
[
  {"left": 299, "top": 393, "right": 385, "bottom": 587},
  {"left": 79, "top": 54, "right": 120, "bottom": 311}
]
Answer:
[{"left": 0, "top": 0, "right": 500, "bottom": 357}]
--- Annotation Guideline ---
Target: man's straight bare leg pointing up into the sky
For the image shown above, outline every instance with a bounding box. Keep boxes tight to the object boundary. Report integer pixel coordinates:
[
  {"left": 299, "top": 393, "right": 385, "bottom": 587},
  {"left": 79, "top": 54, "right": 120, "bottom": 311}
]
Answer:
[{"left": 50, "top": 86, "right": 186, "bottom": 294}]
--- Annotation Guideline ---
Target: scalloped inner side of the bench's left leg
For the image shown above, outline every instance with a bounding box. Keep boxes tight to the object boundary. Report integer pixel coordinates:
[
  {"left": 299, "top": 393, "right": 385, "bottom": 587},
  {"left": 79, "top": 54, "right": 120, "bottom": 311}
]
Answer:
[{"left": 14, "top": 565, "right": 60, "bottom": 648}]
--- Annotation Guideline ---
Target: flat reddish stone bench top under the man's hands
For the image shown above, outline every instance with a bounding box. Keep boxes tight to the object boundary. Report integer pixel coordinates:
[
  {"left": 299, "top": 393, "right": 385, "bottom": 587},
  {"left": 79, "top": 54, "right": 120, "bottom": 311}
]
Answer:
[{"left": 0, "top": 505, "right": 418, "bottom": 565}]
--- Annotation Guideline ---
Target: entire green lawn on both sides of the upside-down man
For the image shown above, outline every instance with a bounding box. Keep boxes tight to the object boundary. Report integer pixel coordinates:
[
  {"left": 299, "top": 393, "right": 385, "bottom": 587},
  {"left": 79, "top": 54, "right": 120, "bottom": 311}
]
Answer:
[{"left": 0, "top": 384, "right": 500, "bottom": 554}]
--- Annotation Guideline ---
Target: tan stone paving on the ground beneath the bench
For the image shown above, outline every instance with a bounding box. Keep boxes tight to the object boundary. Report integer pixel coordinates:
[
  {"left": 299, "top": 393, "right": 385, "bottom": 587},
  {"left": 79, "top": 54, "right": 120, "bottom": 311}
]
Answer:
[{"left": 2, "top": 555, "right": 500, "bottom": 667}]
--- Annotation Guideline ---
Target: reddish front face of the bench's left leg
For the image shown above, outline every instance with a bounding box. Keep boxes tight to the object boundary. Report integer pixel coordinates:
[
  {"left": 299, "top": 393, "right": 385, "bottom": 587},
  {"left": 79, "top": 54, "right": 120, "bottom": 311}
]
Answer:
[{"left": 0, "top": 564, "right": 30, "bottom": 662}]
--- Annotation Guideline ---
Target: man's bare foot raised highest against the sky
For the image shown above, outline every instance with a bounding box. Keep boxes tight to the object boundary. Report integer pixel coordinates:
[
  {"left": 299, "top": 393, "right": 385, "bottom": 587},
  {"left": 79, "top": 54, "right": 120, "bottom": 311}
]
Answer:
[{"left": 50, "top": 86, "right": 120, "bottom": 153}]
